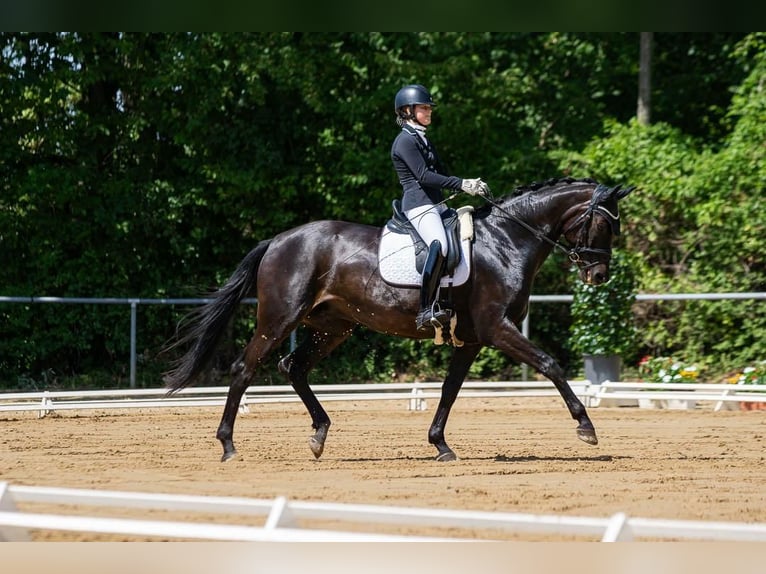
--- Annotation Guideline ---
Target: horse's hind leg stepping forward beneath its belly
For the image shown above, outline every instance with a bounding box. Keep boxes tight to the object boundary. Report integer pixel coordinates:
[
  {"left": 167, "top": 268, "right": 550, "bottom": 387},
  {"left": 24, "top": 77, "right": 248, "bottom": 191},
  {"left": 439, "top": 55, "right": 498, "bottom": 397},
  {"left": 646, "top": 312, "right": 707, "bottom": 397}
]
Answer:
[{"left": 279, "top": 323, "right": 354, "bottom": 458}]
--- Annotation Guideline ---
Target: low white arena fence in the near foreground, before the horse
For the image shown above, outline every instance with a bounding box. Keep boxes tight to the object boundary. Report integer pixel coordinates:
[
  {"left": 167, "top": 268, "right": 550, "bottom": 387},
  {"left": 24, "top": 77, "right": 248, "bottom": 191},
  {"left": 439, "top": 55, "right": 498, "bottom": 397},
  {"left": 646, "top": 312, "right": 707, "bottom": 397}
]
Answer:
[{"left": 0, "top": 483, "right": 766, "bottom": 542}]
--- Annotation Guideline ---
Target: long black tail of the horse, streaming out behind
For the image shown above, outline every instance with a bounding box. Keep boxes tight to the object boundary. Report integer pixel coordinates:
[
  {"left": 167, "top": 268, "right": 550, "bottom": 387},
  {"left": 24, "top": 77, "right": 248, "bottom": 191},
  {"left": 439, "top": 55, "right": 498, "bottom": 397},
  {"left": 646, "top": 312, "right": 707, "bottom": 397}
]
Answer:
[{"left": 164, "top": 239, "right": 271, "bottom": 394}]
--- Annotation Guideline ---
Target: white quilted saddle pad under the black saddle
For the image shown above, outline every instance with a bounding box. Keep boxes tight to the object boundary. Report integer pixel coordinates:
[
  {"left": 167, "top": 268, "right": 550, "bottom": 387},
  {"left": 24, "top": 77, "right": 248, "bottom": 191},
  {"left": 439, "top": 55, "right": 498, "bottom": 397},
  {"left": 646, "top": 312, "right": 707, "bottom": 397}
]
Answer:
[{"left": 378, "top": 206, "right": 473, "bottom": 287}]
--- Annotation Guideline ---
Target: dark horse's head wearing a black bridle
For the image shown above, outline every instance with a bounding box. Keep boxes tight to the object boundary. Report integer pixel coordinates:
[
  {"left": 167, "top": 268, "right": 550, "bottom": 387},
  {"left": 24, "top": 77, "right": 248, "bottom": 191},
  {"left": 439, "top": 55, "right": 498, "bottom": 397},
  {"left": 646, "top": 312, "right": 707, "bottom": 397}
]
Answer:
[{"left": 564, "top": 184, "right": 635, "bottom": 285}]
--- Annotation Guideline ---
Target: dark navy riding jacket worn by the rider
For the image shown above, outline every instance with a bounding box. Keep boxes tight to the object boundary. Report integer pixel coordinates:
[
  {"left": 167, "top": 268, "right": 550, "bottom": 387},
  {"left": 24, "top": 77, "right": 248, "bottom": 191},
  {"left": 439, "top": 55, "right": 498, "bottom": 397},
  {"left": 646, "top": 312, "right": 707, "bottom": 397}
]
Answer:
[{"left": 391, "top": 124, "right": 463, "bottom": 211}]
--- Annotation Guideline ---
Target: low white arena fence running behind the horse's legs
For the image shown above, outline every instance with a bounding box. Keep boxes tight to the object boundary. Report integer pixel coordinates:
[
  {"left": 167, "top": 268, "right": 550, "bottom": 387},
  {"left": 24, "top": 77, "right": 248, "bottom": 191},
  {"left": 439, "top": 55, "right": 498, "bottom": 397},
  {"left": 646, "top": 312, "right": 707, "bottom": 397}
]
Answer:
[{"left": 0, "top": 380, "right": 766, "bottom": 418}]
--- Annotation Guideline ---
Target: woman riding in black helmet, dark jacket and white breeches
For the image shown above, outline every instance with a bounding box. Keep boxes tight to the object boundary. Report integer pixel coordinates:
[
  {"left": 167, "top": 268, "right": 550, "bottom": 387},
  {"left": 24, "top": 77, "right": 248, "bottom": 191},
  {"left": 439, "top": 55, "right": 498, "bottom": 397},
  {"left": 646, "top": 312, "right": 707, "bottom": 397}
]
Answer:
[{"left": 391, "top": 84, "right": 489, "bottom": 331}]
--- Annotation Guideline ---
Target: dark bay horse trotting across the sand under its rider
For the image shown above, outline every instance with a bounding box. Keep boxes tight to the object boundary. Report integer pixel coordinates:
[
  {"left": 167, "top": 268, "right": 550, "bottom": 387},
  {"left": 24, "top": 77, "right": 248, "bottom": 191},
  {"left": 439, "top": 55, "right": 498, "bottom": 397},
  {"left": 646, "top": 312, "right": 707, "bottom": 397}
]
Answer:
[{"left": 165, "top": 179, "right": 633, "bottom": 461}]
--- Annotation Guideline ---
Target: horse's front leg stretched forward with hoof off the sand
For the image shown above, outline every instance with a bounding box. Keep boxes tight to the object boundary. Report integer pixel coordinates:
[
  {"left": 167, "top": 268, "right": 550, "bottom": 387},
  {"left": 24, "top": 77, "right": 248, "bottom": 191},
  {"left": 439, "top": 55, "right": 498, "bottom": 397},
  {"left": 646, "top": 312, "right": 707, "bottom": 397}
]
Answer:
[{"left": 491, "top": 320, "right": 598, "bottom": 445}]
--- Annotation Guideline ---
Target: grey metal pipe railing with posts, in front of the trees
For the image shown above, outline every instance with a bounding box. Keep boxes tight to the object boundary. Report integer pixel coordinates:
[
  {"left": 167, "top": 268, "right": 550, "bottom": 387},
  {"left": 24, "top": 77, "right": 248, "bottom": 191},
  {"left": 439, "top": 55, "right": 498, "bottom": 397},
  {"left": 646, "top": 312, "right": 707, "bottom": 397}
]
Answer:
[{"left": 0, "top": 292, "right": 766, "bottom": 388}]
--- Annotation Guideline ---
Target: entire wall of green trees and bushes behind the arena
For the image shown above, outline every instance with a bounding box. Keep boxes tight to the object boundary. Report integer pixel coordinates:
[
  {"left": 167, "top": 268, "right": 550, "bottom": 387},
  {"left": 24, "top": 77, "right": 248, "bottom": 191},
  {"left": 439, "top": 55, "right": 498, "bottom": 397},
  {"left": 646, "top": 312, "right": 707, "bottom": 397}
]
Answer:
[{"left": 0, "top": 32, "right": 766, "bottom": 387}]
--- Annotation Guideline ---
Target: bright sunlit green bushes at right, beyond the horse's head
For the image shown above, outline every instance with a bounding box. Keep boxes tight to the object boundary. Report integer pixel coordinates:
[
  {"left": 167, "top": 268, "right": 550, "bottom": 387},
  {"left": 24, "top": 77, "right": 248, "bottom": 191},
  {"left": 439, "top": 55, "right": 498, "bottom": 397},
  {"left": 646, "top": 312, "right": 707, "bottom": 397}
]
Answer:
[{"left": 566, "top": 34, "right": 766, "bottom": 372}]
